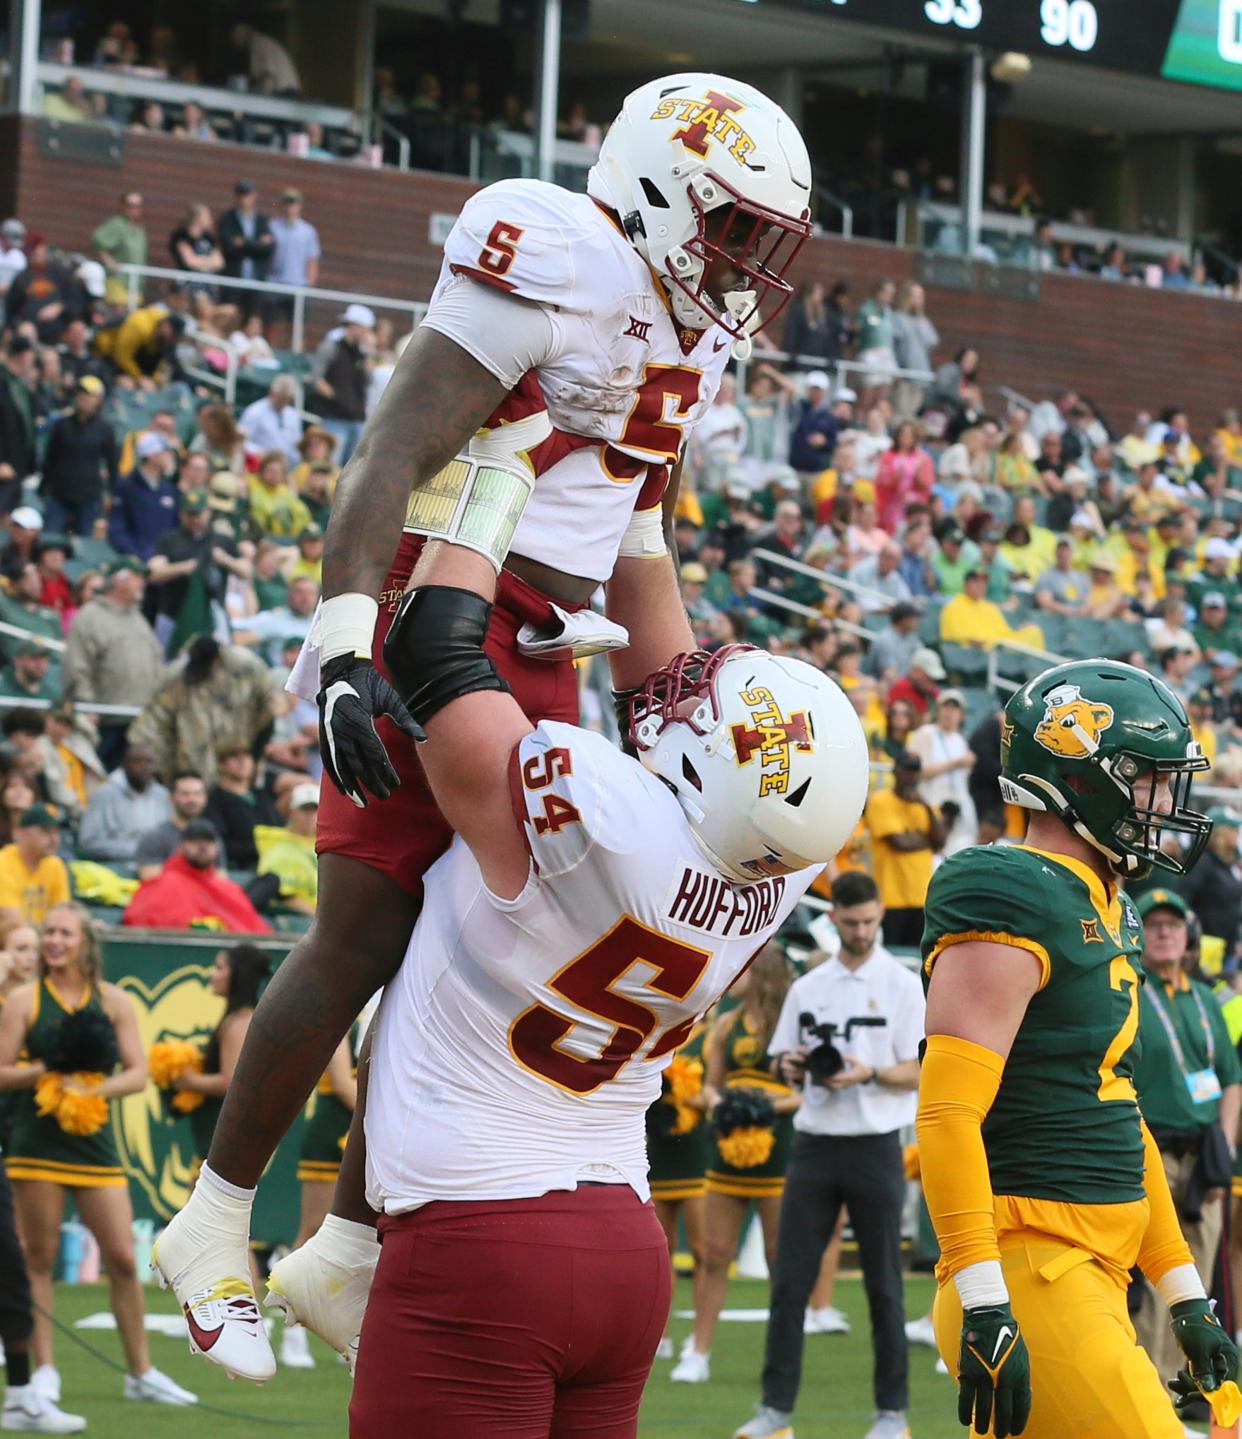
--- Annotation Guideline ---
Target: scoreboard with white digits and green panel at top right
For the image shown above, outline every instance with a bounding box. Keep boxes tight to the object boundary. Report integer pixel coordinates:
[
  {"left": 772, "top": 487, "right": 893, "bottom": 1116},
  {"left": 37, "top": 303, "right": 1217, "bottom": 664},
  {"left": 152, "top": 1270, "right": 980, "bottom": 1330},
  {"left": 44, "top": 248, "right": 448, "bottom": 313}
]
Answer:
[{"left": 769, "top": 0, "right": 1242, "bottom": 91}]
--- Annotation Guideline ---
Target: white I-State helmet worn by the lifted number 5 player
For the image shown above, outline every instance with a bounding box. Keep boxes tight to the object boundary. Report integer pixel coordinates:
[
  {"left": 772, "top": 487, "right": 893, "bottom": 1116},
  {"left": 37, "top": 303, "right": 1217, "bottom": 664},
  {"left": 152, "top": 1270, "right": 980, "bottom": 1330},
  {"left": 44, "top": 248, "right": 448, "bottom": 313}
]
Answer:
[{"left": 587, "top": 73, "right": 810, "bottom": 350}]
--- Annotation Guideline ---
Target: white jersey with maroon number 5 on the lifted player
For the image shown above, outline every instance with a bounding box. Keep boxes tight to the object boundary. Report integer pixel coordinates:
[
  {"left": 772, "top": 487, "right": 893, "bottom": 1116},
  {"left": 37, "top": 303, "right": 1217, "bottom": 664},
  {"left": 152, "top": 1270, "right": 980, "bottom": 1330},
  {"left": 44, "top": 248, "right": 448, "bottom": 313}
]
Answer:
[{"left": 423, "top": 180, "right": 731, "bottom": 580}]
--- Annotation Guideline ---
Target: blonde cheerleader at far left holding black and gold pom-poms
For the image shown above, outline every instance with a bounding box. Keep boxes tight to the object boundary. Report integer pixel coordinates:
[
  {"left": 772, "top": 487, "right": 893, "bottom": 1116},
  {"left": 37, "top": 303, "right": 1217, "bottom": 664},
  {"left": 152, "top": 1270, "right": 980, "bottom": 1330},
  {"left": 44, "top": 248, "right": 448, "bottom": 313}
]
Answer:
[{"left": 0, "top": 904, "right": 194, "bottom": 1404}]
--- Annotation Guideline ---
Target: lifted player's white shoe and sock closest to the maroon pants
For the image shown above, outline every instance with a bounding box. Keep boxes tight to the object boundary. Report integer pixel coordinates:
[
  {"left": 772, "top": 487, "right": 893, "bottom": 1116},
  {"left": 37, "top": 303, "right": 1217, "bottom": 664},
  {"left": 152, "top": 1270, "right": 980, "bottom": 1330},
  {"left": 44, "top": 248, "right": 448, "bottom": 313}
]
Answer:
[{"left": 265, "top": 1215, "right": 380, "bottom": 1374}]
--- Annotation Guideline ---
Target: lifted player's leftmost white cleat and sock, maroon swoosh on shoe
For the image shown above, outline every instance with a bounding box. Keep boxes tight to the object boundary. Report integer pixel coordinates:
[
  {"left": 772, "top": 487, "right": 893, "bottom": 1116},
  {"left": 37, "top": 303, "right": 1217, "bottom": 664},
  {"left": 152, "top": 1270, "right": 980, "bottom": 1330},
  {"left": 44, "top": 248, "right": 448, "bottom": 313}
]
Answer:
[{"left": 151, "top": 1180, "right": 276, "bottom": 1384}]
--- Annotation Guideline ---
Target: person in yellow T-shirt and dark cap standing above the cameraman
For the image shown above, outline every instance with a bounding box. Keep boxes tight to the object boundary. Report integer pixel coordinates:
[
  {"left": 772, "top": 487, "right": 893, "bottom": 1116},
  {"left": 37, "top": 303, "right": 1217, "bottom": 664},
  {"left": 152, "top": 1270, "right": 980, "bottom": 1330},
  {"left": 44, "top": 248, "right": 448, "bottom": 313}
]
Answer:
[{"left": 866, "top": 753, "right": 946, "bottom": 948}]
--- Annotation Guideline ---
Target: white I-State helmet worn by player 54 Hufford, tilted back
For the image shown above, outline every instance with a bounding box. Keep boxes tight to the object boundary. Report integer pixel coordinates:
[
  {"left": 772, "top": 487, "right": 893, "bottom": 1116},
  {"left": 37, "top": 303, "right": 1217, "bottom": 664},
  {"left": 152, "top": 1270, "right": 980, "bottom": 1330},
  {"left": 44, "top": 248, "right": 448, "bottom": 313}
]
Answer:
[{"left": 629, "top": 645, "right": 871, "bottom": 882}]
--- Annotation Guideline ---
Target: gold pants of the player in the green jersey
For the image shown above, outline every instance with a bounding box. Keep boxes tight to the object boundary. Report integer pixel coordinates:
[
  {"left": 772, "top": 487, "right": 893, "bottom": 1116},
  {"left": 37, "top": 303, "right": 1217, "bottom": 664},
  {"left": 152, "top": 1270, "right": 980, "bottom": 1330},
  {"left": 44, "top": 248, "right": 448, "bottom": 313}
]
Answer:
[{"left": 933, "top": 1230, "right": 1184, "bottom": 1439}]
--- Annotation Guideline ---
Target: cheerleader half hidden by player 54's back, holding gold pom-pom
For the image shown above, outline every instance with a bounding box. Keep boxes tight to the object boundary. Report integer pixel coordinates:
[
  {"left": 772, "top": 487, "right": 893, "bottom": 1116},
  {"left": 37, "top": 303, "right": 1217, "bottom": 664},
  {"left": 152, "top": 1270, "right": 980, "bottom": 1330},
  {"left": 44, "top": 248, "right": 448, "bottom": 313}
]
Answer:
[{"left": 646, "top": 1023, "right": 715, "bottom": 1358}]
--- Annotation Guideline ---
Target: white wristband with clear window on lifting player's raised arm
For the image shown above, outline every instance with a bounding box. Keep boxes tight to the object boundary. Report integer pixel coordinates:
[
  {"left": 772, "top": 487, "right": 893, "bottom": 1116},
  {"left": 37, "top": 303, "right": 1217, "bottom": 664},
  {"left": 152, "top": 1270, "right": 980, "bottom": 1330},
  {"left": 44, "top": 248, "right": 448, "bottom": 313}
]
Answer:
[{"left": 406, "top": 412, "right": 551, "bottom": 574}]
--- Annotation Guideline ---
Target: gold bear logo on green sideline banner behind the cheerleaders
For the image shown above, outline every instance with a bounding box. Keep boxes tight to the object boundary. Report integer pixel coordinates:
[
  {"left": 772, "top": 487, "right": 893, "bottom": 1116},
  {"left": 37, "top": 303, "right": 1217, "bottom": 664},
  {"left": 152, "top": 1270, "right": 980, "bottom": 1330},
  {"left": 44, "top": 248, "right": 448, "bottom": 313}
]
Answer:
[{"left": 112, "top": 964, "right": 225, "bottom": 1220}]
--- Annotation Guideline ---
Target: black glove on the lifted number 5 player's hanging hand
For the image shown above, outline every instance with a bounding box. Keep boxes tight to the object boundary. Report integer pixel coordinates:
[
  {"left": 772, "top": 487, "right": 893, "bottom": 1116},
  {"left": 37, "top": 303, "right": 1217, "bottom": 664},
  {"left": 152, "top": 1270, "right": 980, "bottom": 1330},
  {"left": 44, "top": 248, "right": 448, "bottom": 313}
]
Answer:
[{"left": 319, "top": 655, "right": 426, "bottom": 809}]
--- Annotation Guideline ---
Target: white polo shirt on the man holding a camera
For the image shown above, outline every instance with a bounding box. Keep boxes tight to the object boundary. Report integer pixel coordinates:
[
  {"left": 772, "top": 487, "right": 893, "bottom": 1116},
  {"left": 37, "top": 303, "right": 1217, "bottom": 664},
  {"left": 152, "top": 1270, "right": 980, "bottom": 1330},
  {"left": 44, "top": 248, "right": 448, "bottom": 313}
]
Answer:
[{"left": 769, "top": 945, "right": 924, "bottom": 1135}]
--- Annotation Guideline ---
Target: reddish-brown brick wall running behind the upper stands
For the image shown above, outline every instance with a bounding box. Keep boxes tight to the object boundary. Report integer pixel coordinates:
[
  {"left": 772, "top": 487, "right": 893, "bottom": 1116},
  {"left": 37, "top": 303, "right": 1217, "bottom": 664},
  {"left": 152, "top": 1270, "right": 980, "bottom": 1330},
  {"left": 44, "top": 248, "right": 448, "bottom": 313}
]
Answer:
[{"left": 9, "top": 119, "right": 1242, "bottom": 427}]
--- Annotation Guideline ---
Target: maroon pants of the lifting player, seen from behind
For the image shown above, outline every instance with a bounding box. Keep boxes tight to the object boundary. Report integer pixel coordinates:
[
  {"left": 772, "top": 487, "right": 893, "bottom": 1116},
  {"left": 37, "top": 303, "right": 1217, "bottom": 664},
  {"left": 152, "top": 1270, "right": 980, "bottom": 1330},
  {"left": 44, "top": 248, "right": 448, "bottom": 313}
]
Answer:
[{"left": 350, "top": 1184, "right": 672, "bottom": 1439}]
